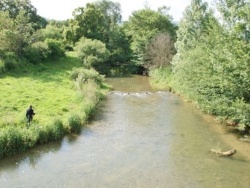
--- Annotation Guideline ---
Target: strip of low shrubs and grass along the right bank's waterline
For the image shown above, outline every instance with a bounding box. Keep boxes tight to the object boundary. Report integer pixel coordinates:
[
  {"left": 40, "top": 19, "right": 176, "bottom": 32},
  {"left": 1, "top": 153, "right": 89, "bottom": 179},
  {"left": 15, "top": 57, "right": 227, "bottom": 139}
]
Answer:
[{"left": 150, "top": 67, "right": 250, "bottom": 133}]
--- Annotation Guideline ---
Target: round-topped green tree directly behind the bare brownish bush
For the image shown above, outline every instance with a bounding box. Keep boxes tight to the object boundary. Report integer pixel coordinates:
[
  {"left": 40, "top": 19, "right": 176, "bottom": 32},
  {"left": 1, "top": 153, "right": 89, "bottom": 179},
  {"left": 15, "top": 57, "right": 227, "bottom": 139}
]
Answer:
[{"left": 124, "top": 8, "right": 176, "bottom": 65}]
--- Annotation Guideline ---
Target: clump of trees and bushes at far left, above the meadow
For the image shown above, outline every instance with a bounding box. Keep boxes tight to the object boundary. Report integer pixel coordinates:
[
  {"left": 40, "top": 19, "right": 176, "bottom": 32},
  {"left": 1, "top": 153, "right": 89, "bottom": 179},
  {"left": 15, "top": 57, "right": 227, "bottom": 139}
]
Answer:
[{"left": 0, "top": 0, "right": 64, "bottom": 69}]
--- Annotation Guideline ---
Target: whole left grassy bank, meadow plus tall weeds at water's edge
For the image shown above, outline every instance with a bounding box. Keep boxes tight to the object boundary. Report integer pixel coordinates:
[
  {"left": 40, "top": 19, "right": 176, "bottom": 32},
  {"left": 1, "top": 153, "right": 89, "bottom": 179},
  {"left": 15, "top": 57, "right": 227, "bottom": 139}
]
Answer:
[{"left": 0, "top": 53, "right": 107, "bottom": 158}]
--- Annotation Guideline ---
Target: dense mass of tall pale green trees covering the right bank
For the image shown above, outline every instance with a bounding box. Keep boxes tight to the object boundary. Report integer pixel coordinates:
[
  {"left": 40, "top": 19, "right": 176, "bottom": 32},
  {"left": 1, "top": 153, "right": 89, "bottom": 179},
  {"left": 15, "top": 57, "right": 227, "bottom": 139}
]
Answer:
[{"left": 152, "top": 0, "right": 250, "bottom": 131}]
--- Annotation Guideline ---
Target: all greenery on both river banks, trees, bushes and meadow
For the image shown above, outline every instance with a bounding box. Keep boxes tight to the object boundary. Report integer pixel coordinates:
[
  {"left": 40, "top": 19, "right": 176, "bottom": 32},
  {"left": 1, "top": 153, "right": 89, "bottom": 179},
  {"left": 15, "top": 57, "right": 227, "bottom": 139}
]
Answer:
[{"left": 0, "top": 0, "right": 250, "bottom": 157}]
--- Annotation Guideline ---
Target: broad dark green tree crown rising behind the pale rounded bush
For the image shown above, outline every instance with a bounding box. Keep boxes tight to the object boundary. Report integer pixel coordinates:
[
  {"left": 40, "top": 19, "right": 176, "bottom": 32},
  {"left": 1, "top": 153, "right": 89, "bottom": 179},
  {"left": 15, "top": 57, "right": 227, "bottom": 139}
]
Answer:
[{"left": 67, "top": 0, "right": 121, "bottom": 44}]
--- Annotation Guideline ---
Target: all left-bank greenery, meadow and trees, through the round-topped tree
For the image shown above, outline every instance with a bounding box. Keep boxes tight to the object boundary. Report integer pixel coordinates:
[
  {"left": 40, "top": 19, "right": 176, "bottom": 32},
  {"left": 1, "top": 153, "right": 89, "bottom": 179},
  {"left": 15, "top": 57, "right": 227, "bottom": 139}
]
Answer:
[{"left": 0, "top": 0, "right": 176, "bottom": 158}]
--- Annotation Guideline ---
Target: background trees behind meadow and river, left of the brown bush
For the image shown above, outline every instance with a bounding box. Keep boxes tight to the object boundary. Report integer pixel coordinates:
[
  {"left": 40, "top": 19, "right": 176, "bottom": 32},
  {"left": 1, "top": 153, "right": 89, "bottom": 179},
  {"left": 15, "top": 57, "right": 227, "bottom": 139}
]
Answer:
[{"left": 0, "top": 0, "right": 176, "bottom": 76}]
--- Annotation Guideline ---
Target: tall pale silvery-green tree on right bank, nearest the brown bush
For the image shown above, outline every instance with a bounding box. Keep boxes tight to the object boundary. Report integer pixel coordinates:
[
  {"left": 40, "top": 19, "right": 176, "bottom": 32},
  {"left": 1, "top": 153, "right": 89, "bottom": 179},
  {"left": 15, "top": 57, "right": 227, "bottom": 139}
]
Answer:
[{"left": 171, "top": 0, "right": 221, "bottom": 101}]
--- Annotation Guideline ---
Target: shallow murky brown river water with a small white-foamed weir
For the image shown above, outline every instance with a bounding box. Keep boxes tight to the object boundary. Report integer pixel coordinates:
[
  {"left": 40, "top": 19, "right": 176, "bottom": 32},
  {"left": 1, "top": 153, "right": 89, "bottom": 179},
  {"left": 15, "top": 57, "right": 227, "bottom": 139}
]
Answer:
[{"left": 0, "top": 76, "right": 250, "bottom": 188}]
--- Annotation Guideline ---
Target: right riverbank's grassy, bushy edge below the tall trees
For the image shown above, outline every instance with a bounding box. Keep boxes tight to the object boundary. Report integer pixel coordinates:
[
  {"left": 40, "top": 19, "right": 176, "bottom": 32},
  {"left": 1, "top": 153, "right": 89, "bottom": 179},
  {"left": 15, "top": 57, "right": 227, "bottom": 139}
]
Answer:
[{"left": 150, "top": 67, "right": 250, "bottom": 137}]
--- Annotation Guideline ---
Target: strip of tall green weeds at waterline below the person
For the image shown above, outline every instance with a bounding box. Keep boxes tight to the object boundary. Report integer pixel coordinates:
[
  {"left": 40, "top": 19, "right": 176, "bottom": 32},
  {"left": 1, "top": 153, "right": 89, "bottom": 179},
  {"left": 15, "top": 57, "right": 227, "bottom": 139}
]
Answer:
[{"left": 0, "top": 117, "right": 79, "bottom": 158}]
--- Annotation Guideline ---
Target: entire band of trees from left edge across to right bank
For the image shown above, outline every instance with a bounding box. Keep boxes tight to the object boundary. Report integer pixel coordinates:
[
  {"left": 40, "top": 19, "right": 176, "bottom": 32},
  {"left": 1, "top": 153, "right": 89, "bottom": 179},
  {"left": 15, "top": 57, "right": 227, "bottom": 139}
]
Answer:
[{"left": 0, "top": 0, "right": 250, "bottom": 134}]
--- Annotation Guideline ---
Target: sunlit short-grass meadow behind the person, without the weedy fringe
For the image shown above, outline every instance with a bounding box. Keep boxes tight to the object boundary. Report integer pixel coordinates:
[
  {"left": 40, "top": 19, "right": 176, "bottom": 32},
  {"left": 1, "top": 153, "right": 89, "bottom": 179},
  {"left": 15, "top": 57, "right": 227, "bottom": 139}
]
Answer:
[{"left": 0, "top": 52, "right": 84, "bottom": 126}]
